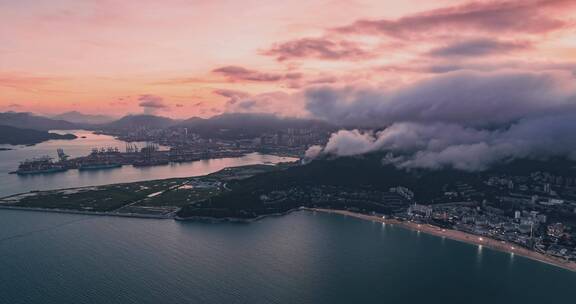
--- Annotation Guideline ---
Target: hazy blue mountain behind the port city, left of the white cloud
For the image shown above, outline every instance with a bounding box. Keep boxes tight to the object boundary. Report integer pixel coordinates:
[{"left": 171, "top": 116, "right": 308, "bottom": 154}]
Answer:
[{"left": 175, "top": 113, "right": 331, "bottom": 138}]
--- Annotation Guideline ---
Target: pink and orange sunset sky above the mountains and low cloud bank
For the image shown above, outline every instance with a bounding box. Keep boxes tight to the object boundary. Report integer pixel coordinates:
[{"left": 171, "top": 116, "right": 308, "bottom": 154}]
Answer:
[{"left": 0, "top": 0, "right": 576, "bottom": 118}]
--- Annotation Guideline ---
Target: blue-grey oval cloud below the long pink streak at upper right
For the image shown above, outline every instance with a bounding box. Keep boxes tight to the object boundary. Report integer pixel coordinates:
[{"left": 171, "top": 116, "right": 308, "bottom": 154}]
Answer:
[{"left": 429, "top": 38, "right": 532, "bottom": 57}]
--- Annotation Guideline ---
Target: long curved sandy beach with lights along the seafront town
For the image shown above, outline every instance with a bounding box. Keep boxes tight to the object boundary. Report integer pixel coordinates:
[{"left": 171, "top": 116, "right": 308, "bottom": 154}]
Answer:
[{"left": 306, "top": 208, "right": 576, "bottom": 272}]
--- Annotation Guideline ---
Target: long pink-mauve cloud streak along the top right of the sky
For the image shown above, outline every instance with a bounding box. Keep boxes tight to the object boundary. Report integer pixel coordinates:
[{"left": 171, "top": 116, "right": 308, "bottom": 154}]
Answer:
[{"left": 334, "top": 0, "right": 576, "bottom": 38}]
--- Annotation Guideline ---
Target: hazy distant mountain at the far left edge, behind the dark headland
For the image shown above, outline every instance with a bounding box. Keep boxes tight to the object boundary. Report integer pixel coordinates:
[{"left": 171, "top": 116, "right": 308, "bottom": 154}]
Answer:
[{"left": 0, "top": 112, "right": 79, "bottom": 131}]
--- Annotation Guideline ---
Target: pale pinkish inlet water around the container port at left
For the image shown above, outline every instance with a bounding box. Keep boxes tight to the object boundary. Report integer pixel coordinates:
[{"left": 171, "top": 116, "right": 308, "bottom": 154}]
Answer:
[{"left": 0, "top": 130, "right": 294, "bottom": 197}]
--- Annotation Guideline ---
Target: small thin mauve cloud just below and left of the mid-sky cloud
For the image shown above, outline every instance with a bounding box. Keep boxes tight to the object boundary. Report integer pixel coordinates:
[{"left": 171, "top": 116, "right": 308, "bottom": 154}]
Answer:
[{"left": 212, "top": 65, "right": 302, "bottom": 82}]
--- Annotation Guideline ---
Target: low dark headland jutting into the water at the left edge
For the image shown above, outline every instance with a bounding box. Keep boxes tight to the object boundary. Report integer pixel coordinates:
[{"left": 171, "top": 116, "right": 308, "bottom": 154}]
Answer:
[{"left": 0, "top": 125, "right": 76, "bottom": 145}]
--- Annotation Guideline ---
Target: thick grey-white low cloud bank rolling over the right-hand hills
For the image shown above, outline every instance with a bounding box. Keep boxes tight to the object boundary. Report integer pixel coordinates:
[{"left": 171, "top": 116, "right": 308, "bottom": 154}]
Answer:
[{"left": 306, "top": 72, "right": 576, "bottom": 171}]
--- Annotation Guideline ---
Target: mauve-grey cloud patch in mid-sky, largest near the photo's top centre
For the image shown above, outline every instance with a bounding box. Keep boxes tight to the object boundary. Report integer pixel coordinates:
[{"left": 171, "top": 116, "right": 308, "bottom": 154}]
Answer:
[{"left": 263, "top": 38, "right": 373, "bottom": 61}]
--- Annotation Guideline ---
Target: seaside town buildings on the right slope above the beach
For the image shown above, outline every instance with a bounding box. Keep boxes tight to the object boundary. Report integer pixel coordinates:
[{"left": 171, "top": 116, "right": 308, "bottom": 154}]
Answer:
[{"left": 398, "top": 172, "right": 576, "bottom": 260}]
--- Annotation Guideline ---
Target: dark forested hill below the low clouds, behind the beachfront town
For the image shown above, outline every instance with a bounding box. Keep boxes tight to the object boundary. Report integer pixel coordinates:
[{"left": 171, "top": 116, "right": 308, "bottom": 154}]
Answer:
[{"left": 178, "top": 153, "right": 576, "bottom": 218}]
